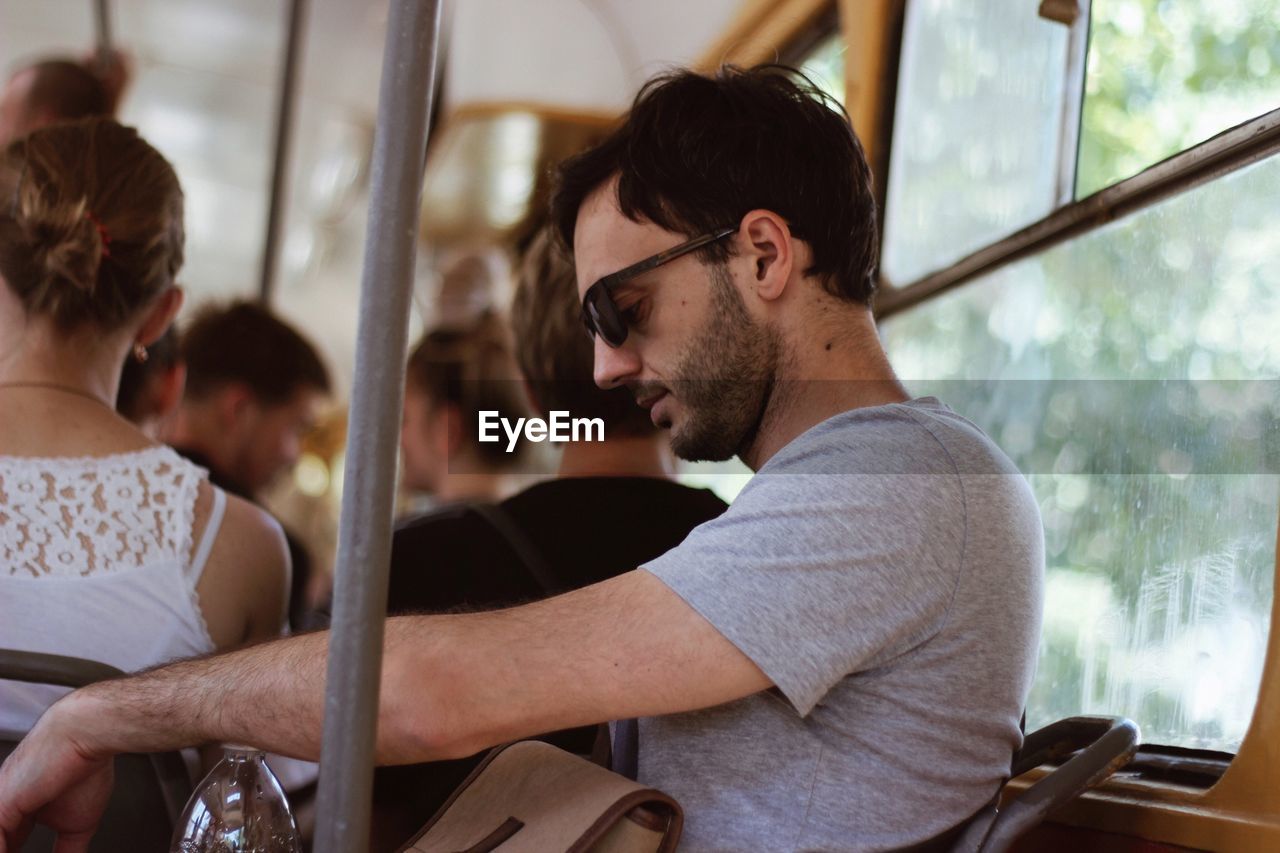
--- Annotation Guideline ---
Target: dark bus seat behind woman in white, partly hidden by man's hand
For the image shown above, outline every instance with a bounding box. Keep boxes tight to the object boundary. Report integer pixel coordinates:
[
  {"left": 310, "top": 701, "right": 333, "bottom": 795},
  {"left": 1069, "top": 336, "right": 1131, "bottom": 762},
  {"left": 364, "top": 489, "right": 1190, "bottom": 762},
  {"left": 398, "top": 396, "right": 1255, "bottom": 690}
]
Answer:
[{"left": 0, "top": 649, "right": 192, "bottom": 853}]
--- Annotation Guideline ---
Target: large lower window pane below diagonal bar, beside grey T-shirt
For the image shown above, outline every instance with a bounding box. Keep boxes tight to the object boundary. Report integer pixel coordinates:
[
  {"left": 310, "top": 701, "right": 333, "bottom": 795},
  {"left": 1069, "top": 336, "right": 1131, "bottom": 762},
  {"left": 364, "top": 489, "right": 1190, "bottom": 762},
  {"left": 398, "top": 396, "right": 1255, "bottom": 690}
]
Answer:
[{"left": 883, "top": 151, "right": 1280, "bottom": 751}]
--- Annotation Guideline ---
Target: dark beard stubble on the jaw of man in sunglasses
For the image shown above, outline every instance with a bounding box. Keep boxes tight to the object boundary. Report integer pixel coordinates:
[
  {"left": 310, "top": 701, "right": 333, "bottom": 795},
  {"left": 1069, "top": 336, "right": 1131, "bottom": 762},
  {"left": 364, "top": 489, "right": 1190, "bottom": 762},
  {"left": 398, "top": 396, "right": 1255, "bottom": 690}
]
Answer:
[{"left": 669, "top": 264, "right": 782, "bottom": 462}]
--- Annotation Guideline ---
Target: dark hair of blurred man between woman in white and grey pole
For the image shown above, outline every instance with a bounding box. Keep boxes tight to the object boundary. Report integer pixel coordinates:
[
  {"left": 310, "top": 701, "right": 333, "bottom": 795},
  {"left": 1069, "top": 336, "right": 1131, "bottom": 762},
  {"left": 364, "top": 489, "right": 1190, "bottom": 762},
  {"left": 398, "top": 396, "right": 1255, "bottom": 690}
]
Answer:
[{"left": 182, "top": 302, "right": 330, "bottom": 406}]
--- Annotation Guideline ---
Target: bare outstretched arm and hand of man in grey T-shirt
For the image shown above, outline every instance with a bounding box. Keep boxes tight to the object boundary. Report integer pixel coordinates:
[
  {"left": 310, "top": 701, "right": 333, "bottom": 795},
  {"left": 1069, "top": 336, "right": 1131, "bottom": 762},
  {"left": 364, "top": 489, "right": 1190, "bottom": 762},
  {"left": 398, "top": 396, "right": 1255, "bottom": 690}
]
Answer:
[{"left": 0, "top": 571, "right": 769, "bottom": 853}]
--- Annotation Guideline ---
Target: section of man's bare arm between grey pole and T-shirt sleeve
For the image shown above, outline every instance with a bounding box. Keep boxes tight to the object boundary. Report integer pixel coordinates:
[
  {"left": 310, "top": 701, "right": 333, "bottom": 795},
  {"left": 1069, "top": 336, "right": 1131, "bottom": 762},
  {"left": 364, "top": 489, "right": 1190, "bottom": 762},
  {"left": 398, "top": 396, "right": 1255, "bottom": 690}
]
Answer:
[{"left": 379, "top": 571, "right": 772, "bottom": 762}]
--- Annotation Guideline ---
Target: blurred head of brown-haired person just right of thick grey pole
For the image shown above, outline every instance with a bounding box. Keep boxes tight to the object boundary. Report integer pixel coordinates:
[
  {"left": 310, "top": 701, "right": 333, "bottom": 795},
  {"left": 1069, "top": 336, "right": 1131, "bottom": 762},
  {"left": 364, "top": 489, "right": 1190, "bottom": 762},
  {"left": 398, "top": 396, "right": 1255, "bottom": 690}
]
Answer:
[{"left": 401, "top": 313, "right": 529, "bottom": 503}]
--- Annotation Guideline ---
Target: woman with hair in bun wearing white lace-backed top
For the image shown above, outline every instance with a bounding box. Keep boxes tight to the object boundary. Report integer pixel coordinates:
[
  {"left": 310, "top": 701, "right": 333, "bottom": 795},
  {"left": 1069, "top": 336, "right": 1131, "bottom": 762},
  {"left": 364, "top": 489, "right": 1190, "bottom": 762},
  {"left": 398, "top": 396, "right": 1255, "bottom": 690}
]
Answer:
[{"left": 0, "top": 119, "right": 288, "bottom": 730}]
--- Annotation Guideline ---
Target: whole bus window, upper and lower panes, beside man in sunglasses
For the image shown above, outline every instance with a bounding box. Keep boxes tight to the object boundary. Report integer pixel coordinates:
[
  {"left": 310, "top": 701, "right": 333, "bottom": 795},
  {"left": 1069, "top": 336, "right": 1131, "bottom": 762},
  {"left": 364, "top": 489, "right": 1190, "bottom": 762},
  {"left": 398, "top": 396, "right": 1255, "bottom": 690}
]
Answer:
[{"left": 881, "top": 0, "right": 1280, "bottom": 752}]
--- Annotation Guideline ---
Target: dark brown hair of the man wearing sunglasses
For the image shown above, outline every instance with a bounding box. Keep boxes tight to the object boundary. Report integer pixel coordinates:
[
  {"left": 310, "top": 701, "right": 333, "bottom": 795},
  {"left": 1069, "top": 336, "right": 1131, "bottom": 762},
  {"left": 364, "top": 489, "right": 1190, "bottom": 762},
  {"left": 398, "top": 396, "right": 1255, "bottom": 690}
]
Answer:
[{"left": 552, "top": 65, "right": 878, "bottom": 304}]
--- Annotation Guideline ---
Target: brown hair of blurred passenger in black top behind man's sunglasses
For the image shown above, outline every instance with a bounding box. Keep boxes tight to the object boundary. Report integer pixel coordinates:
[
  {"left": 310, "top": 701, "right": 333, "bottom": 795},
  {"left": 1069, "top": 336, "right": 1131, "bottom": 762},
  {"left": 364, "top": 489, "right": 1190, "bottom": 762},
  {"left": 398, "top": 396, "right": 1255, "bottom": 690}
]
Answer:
[{"left": 511, "top": 228, "right": 658, "bottom": 437}]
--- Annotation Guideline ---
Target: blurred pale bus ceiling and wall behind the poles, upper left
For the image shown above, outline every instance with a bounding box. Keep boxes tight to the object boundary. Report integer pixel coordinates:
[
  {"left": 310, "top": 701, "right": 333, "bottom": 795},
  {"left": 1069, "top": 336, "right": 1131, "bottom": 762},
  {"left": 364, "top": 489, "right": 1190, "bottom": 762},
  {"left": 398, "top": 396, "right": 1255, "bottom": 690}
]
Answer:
[{"left": 0, "top": 0, "right": 740, "bottom": 396}]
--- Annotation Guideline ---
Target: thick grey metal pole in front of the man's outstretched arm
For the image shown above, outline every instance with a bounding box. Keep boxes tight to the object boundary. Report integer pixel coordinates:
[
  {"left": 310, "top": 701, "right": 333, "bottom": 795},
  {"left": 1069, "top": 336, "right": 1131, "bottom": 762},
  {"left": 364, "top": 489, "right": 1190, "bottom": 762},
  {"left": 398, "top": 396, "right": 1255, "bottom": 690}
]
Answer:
[{"left": 315, "top": 0, "right": 443, "bottom": 853}]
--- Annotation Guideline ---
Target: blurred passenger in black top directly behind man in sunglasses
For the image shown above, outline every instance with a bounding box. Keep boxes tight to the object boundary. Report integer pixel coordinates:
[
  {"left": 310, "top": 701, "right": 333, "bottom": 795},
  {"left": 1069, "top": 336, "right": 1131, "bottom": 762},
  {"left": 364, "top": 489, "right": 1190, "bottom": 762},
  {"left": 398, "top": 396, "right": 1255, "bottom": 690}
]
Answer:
[{"left": 372, "top": 225, "right": 726, "bottom": 850}]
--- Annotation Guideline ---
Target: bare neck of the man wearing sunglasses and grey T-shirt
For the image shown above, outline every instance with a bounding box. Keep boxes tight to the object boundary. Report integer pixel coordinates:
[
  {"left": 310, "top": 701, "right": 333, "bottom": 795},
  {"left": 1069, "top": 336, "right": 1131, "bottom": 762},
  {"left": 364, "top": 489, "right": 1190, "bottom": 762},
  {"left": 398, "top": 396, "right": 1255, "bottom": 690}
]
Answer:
[{"left": 740, "top": 303, "right": 910, "bottom": 470}]
